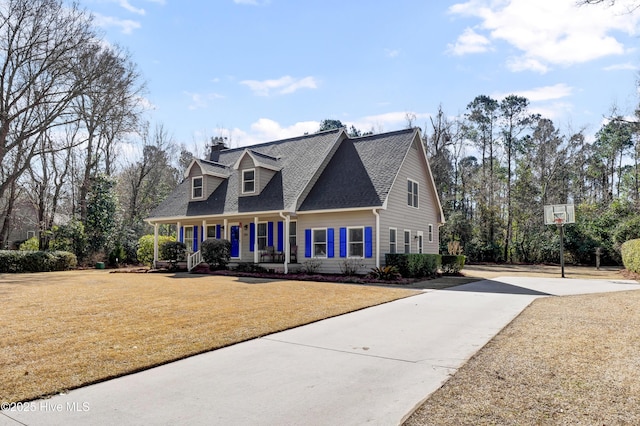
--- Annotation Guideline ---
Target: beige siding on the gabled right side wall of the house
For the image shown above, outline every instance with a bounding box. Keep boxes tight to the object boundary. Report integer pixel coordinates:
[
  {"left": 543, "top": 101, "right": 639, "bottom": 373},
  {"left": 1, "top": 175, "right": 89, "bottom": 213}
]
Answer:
[{"left": 380, "top": 139, "right": 440, "bottom": 265}]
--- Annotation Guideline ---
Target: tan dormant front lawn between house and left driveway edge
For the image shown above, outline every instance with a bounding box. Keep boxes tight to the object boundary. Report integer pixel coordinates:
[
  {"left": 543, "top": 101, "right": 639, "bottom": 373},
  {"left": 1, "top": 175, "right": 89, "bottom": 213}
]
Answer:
[{"left": 0, "top": 270, "right": 416, "bottom": 402}]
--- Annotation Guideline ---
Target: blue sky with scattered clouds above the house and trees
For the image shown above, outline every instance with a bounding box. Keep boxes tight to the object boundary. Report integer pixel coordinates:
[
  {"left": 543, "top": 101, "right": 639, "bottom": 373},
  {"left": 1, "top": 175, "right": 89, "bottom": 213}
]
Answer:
[{"left": 81, "top": 0, "right": 640, "bottom": 151}]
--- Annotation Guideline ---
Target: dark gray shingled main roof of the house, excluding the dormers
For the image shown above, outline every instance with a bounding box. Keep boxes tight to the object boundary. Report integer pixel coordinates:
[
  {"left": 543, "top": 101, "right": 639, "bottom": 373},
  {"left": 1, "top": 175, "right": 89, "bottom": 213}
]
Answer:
[{"left": 150, "top": 129, "right": 418, "bottom": 220}]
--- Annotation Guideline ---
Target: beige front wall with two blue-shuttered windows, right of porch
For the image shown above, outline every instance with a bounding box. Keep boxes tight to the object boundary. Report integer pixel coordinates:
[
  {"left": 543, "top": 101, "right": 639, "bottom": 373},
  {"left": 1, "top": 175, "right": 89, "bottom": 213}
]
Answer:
[{"left": 297, "top": 210, "right": 377, "bottom": 274}]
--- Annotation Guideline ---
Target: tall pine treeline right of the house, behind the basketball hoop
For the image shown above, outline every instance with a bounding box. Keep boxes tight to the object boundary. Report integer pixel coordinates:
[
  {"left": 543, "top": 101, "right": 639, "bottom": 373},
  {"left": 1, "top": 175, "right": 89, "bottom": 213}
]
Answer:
[{"left": 424, "top": 95, "right": 640, "bottom": 264}]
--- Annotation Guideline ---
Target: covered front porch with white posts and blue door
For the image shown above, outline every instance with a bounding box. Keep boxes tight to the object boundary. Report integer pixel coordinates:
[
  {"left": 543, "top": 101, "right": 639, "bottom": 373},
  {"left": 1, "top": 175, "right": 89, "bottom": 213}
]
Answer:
[{"left": 151, "top": 212, "right": 298, "bottom": 273}]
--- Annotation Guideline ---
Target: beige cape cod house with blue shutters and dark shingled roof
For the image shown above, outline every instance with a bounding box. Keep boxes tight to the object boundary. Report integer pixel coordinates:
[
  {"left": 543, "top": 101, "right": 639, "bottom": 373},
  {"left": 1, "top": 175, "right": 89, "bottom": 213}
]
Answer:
[{"left": 147, "top": 129, "right": 444, "bottom": 273}]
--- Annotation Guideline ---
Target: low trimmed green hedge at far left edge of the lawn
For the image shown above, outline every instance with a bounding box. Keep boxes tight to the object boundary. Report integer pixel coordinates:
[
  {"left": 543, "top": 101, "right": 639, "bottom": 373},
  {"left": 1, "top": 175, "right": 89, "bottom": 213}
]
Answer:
[{"left": 0, "top": 250, "right": 78, "bottom": 273}]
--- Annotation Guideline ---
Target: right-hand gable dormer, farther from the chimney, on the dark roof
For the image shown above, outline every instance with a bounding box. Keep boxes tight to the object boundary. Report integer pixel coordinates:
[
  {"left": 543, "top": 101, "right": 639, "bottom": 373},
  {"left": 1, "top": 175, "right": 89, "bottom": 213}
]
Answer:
[{"left": 233, "top": 149, "right": 282, "bottom": 197}]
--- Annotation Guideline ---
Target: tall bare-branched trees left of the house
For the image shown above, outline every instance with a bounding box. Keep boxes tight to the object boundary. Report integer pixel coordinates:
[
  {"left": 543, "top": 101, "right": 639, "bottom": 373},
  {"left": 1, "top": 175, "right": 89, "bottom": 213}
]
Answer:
[{"left": 0, "top": 0, "right": 190, "bottom": 260}]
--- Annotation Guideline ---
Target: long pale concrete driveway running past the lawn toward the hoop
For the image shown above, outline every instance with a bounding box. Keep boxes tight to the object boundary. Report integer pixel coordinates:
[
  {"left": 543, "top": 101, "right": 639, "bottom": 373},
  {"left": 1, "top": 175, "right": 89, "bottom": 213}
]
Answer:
[{"left": 0, "top": 277, "right": 640, "bottom": 426}]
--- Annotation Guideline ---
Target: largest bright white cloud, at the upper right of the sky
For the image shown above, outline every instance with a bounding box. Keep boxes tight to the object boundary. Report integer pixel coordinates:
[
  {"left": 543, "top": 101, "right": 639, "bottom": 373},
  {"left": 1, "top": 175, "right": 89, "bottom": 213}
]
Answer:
[{"left": 449, "top": 0, "right": 640, "bottom": 72}]
